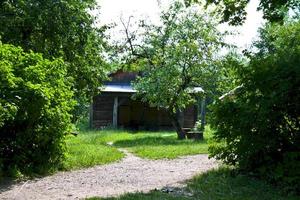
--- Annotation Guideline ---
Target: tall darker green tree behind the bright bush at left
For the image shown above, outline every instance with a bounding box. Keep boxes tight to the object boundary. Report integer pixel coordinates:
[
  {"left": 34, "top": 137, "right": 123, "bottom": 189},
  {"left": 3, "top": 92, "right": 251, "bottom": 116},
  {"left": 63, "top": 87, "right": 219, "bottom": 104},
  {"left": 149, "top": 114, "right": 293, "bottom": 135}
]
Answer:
[{"left": 0, "top": 0, "right": 106, "bottom": 119}]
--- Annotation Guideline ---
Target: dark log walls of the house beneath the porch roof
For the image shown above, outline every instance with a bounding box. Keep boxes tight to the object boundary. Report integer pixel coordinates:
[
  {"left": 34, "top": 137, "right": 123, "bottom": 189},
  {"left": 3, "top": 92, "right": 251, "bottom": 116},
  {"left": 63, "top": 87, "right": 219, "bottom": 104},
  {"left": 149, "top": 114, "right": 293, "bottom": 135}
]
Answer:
[{"left": 92, "top": 92, "right": 197, "bottom": 130}]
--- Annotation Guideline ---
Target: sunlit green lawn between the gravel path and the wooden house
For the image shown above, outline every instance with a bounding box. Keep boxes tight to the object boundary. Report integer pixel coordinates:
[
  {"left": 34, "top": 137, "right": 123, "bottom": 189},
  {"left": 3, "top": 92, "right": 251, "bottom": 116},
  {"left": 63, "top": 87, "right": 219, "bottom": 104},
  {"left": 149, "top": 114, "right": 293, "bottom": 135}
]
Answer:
[{"left": 63, "top": 127, "right": 212, "bottom": 170}]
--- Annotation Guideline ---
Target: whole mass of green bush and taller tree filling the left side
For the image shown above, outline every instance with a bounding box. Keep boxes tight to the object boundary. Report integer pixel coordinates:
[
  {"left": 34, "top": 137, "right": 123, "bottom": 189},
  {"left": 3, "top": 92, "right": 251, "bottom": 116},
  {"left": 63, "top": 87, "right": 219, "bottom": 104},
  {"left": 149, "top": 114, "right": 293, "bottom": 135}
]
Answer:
[{"left": 0, "top": 0, "right": 106, "bottom": 176}]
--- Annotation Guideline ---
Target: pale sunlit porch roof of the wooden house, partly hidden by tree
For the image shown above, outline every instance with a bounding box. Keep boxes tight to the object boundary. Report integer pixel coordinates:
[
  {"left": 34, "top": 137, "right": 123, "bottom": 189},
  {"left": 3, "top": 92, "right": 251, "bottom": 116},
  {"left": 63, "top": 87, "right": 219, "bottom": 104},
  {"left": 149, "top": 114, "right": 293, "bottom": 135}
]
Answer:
[{"left": 99, "top": 84, "right": 204, "bottom": 93}]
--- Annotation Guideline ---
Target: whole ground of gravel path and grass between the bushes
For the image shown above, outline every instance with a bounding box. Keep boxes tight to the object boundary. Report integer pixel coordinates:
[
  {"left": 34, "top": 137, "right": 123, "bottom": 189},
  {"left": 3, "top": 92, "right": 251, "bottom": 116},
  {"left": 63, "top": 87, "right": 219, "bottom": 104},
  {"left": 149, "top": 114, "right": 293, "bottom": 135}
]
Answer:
[{"left": 0, "top": 128, "right": 300, "bottom": 200}]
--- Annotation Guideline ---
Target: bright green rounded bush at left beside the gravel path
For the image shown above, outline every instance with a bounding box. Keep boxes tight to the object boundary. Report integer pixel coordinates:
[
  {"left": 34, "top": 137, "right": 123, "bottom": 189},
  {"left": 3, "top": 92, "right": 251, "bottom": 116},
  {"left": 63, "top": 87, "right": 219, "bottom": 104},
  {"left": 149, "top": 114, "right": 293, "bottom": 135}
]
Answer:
[{"left": 0, "top": 43, "right": 74, "bottom": 175}]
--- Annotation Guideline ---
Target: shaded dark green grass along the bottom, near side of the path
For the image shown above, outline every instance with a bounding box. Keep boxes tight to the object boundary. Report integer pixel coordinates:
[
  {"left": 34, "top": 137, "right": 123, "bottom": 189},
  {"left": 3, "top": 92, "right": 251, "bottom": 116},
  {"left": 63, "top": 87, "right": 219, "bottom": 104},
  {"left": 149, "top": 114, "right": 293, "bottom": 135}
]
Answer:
[{"left": 90, "top": 168, "right": 299, "bottom": 200}]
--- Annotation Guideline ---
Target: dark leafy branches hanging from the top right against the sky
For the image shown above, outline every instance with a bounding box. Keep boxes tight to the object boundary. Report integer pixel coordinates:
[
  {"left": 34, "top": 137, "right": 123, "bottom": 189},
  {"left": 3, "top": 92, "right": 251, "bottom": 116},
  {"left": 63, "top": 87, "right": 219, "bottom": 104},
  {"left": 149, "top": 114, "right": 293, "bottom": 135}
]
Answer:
[{"left": 185, "top": 0, "right": 300, "bottom": 25}]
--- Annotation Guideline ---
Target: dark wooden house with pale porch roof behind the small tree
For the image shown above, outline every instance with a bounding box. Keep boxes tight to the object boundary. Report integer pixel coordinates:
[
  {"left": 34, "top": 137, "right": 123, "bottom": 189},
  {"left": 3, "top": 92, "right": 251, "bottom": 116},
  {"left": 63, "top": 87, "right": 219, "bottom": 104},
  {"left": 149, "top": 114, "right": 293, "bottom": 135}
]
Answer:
[{"left": 90, "top": 71, "right": 203, "bottom": 130}]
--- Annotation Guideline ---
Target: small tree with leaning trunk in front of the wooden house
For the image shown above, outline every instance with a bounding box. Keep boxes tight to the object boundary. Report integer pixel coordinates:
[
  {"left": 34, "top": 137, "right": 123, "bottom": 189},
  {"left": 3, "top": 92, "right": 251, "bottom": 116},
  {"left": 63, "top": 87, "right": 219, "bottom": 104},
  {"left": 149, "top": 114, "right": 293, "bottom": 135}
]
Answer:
[{"left": 118, "top": 2, "right": 224, "bottom": 139}]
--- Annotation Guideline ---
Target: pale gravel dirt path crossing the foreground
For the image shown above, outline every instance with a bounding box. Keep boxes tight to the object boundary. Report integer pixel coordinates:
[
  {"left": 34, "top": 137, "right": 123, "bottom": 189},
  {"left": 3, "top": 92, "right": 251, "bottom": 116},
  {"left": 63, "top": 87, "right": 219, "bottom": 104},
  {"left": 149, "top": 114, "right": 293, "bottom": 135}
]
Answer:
[{"left": 0, "top": 149, "right": 217, "bottom": 200}]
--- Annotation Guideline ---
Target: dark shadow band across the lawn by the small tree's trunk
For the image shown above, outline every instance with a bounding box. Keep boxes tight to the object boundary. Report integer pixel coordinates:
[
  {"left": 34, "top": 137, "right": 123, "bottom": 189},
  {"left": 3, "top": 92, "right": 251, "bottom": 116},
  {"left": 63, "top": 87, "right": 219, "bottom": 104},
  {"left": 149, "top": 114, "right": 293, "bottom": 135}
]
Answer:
[{"left": 114, "top": 136, "right": 207, "bottom": 148}]
